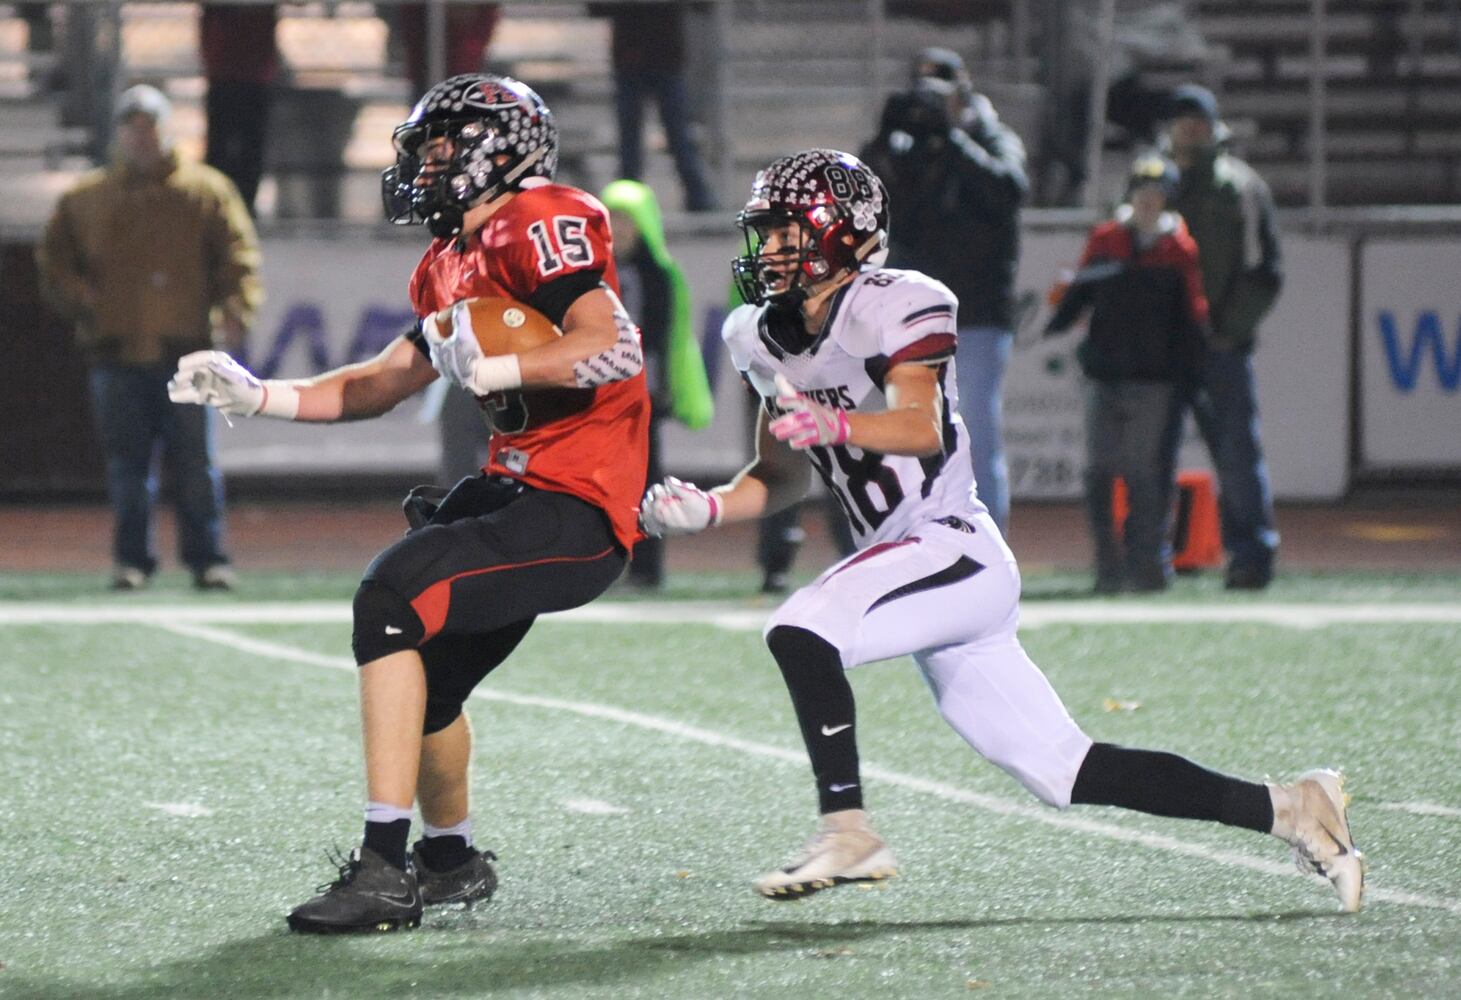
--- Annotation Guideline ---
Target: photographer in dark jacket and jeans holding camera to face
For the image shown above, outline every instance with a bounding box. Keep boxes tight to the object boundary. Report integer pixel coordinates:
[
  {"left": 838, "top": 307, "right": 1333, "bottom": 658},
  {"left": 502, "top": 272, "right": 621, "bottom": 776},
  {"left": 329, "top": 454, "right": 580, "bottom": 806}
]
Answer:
[{"left": 862, "top": 48, "right": 1029, "bottom": 531}]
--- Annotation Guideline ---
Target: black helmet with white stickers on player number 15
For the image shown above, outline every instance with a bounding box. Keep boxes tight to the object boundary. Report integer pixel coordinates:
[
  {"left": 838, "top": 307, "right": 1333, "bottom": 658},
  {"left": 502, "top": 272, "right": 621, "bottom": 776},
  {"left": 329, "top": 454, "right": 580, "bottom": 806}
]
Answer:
[{"left": 381, "top": 73, "right": 558, "bottom": 238}]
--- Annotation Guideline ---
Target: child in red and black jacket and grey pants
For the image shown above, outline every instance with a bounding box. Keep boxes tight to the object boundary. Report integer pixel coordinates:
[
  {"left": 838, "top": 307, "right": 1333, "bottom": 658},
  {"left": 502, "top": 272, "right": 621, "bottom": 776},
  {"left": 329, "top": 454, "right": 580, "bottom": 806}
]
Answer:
[{"left": 1046, "top": 156, "right": 1208, "bottom": 594}]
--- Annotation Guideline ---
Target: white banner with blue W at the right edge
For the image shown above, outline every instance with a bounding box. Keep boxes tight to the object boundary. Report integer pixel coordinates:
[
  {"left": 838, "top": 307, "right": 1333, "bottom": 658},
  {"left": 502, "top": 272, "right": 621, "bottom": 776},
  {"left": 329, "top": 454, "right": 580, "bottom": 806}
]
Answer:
[{"left": 1359, "top": 237, "right": 1461, "bottom": 469}]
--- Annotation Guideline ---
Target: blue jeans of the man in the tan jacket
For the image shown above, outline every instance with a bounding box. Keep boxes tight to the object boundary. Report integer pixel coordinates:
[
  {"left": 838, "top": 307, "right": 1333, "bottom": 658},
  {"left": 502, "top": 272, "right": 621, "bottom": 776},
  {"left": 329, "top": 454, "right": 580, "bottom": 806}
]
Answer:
[{"left": 91, "top": 365, "right": 228, "bottom": 573}]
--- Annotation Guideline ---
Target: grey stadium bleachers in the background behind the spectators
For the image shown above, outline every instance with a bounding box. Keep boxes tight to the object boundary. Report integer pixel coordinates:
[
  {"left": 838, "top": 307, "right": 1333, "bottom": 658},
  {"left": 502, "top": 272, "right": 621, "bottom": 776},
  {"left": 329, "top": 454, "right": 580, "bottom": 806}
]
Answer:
[{"left": 0, "top": 0, "right": 1461, "bottom": 221}]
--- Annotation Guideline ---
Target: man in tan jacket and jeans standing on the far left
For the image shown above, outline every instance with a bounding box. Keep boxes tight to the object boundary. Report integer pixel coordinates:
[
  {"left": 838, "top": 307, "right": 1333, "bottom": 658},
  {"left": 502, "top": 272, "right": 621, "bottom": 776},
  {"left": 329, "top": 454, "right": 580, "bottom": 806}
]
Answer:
[{"left": 37, "top": 86, "right": 262, "bottom": 591}]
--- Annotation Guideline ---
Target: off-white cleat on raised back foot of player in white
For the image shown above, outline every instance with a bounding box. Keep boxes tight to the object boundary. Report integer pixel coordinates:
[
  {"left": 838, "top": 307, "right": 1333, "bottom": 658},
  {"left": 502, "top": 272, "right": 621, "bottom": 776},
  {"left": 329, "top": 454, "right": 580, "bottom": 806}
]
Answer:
[{"left": 1274, "top": 770, "right": 1365, "bottom": 914}]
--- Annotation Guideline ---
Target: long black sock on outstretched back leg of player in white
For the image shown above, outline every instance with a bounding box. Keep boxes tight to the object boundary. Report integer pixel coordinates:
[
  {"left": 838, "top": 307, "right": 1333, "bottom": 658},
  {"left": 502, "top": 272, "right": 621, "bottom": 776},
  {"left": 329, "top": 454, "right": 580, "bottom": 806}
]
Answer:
[{"left": 1071, "top": 743, "right": 1274, "bottom": 833}]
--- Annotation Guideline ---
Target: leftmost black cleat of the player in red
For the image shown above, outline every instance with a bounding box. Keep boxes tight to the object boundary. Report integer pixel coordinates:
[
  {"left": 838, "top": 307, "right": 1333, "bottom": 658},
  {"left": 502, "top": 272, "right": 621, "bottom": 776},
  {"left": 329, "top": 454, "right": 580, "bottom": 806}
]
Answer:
[{"left": 289, "top": 846, "right": 422, "bottom": 934}]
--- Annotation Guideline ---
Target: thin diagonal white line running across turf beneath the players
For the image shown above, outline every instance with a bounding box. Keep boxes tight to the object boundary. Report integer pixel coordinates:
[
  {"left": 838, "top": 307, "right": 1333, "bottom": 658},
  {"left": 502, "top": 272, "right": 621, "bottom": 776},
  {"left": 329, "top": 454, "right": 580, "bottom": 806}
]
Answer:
[{"left": 152, "top": 621, "right": 1461, "bottom": 914}]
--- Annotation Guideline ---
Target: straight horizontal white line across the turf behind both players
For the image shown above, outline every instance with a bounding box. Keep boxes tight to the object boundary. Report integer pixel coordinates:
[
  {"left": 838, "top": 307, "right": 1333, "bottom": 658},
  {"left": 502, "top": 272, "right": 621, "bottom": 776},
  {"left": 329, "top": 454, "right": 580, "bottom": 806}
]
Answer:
[{"left": 0, "top": 601, "right": 1461, "bottom": 632}]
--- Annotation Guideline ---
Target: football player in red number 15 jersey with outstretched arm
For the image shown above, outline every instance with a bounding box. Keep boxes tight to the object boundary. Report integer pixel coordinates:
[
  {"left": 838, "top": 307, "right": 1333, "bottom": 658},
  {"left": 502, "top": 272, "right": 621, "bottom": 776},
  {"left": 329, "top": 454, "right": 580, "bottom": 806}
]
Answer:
[{"left": 169, "top": 73, "right": 649, "bottom": 933}]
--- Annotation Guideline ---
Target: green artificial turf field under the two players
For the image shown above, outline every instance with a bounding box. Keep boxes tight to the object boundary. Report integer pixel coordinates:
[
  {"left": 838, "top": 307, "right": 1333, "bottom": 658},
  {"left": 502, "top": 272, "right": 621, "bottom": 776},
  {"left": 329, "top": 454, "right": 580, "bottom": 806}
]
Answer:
[{"left": 0, "top": 575, "right": 1461, "bottom": 1000}]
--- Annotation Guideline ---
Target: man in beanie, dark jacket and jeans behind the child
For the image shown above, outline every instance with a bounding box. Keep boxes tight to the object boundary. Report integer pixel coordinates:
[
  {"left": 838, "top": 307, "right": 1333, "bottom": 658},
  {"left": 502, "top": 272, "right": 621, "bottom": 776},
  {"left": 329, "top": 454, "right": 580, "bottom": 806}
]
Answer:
[{"left": 1164, "top": 83, "right": 1283, "bottom": 589}]
